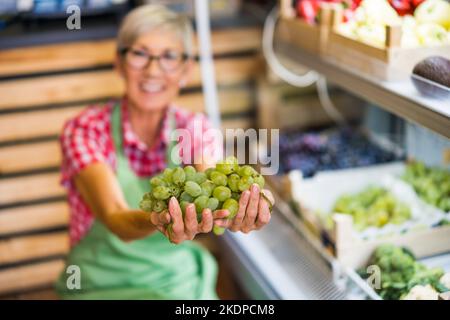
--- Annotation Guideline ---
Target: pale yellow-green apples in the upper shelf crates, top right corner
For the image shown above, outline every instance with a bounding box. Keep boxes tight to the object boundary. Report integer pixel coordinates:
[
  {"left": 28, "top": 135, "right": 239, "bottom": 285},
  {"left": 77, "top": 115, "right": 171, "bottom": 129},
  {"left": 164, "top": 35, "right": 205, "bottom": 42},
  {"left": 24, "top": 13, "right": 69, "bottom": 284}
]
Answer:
[{"left": 336, "top": 0, "right": 450, "bottom": 48}]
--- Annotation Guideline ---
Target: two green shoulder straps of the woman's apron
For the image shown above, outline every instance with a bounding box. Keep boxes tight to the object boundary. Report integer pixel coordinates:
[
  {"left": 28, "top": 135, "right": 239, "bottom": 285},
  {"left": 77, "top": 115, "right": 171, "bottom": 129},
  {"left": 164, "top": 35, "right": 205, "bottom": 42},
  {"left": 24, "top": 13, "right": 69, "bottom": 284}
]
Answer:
[{"left": 111, "top": 103, "right": 181, "bottom": 172}]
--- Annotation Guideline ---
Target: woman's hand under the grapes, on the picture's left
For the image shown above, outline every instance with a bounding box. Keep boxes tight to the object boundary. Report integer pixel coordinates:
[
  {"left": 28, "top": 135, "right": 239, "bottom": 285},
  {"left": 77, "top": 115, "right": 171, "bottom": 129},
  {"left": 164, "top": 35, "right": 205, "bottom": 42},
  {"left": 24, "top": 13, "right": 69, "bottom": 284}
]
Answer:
[{"left": 150, "top": 197, "right": 229, "bottom": 244}]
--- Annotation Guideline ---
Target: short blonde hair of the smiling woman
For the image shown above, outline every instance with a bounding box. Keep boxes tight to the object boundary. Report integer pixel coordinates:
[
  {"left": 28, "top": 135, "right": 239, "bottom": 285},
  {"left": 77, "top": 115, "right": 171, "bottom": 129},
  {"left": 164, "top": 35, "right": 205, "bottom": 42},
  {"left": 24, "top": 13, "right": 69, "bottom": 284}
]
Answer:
[{"left": 117, "top": 4, "right": 193, "bottom": 56}]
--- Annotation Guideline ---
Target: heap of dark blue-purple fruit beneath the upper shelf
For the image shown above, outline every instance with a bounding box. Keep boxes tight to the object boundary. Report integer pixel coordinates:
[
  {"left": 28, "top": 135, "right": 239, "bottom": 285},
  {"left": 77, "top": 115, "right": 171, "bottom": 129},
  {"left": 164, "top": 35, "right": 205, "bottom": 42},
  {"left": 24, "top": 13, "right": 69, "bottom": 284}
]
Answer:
[{"left": 280, "top": 127, "right": 400, "bottom": 177}]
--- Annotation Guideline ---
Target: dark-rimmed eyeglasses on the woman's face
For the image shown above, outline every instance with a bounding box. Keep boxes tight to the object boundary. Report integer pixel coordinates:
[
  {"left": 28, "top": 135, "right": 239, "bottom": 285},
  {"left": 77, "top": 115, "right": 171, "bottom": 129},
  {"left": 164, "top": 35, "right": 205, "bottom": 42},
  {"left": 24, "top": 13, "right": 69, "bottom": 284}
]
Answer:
[{"left": 119, "top": 48, "right": 189, "bottom": 72}]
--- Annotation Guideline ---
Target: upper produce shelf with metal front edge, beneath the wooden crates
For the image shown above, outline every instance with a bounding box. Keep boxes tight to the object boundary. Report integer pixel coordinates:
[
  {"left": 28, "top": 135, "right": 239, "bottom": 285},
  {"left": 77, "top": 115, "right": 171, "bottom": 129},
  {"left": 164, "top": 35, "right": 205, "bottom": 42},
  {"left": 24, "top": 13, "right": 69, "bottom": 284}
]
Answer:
[{"left": 274, "top": 38, "right": 450, "bottom": 138}]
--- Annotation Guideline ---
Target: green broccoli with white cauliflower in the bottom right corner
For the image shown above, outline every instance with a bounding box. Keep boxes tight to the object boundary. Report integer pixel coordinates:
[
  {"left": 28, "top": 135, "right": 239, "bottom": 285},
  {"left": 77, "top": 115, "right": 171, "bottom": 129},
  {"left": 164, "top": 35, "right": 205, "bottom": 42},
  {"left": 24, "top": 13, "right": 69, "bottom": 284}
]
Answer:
[{"left": 358, "top": 244, "right": 450, "bottom": 300}]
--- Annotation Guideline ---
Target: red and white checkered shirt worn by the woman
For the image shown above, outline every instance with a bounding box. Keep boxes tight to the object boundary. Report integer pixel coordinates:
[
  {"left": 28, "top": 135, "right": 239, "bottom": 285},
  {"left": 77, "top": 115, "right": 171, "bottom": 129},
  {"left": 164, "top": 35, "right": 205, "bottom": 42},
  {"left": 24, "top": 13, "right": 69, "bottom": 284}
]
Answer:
[{"left": 60, "top": 99, "right": 221, "bottom": 246}]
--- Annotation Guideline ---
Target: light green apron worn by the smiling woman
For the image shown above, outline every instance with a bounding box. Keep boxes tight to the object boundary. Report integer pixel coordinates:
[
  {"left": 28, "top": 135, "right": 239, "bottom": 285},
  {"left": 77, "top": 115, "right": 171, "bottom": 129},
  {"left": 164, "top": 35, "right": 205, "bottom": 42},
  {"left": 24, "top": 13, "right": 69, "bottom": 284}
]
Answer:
[{"left": 55, "top": 105, "right": 217, "bottom": 299}]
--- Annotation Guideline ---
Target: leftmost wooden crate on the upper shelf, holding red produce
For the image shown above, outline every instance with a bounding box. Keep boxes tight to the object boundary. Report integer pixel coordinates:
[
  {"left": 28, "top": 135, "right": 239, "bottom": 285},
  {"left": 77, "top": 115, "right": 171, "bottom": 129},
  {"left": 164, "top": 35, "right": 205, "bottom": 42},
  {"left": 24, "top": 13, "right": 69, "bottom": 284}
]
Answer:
[{"left": 278, "top": 0, "right": 332, "bottom": 54}]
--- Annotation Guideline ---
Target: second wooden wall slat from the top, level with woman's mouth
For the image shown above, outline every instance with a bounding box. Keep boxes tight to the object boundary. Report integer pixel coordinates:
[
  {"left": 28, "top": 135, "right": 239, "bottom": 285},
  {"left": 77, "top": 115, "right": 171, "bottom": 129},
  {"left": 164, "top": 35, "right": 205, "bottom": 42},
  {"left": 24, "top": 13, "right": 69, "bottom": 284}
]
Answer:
[{"left": 0, "top": 57, "right": 261, "bottom": 110}]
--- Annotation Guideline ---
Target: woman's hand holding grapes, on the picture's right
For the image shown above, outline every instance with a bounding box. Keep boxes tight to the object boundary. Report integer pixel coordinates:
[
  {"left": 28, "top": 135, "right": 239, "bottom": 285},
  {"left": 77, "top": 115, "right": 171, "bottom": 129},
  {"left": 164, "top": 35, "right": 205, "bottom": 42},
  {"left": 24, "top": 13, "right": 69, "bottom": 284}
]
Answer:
[{"left": 214, "top": 184, "right": 275, "bottom": 233}]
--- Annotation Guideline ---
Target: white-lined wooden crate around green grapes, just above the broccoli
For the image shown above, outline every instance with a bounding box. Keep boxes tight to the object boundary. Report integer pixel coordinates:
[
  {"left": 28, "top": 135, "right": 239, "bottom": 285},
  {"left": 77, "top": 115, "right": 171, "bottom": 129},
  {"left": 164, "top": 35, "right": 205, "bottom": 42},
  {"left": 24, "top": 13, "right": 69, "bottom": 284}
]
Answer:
[{"left": 285, "top": 163, "right": 450, "bottom": 269}]
